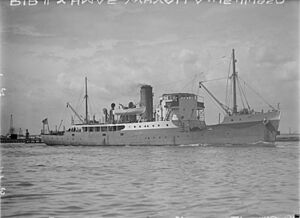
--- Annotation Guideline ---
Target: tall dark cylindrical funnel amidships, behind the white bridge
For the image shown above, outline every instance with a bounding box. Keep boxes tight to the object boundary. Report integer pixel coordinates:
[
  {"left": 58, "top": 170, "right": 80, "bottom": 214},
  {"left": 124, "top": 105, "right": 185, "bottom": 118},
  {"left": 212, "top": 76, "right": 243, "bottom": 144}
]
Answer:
[{"left": 140, "top": 85, "right": 153, "bottom": 121}]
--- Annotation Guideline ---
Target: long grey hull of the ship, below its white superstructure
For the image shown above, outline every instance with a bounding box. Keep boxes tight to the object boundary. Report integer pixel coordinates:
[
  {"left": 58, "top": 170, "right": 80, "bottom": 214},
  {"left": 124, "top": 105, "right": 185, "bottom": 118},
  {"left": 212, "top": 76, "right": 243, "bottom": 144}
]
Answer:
[{"left": 42, "top": 115, "right": 279, "bottom": 146}]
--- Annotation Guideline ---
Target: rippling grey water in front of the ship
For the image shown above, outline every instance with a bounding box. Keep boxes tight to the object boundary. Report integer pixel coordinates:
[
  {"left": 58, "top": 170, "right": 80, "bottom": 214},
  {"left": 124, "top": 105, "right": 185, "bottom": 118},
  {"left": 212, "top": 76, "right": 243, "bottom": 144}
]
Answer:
[{"left": 1, "top": 143, "right": 299, "bottom": 218}]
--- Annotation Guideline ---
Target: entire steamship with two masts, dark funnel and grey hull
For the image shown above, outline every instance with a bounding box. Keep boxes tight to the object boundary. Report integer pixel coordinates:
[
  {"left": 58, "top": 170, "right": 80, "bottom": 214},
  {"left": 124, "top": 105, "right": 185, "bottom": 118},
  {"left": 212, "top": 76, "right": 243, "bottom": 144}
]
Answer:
[{"left": 41, "top": 49, "right": 280, "bottom": 146}]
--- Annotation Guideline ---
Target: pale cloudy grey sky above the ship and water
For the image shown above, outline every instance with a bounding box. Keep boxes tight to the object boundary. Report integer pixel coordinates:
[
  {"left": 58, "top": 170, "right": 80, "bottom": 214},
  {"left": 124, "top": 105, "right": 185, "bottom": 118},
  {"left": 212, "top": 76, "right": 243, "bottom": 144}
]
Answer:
[{"left": 0, "top": 0, "right": 300, "bottom": 135}]
